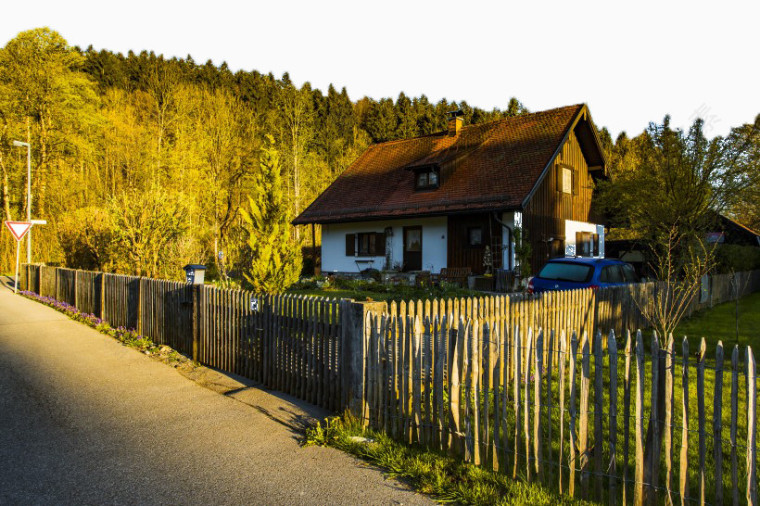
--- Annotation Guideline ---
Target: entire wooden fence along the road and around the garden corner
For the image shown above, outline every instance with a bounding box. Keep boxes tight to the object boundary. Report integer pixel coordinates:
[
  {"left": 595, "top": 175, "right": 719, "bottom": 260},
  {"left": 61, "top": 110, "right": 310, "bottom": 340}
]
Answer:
[{"left": 20, "top": 265, "right": 760, "bottom": 504}]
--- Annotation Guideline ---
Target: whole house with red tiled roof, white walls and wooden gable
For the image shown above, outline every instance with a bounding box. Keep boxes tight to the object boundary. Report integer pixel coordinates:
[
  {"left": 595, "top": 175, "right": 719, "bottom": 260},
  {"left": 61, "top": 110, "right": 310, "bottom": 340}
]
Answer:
[{"left": 293, "top": 104, "right": 607, "bottom": 273}]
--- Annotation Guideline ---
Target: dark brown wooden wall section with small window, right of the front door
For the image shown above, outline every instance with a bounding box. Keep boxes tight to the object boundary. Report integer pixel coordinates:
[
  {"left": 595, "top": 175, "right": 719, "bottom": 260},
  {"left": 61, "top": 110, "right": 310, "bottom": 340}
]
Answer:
[{"left": 446, "top": 214, "right": 502, "bottom": 274}]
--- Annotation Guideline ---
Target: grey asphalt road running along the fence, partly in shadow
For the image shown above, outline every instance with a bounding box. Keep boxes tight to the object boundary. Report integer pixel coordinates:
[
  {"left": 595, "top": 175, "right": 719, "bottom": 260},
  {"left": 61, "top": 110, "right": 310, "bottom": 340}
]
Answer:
[{"left": 0, "top": 280, "right": 431, "bottom": 504}]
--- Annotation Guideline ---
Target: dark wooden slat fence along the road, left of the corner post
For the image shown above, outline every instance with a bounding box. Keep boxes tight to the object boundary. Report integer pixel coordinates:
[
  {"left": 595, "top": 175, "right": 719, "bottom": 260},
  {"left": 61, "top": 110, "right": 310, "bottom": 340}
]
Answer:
[{"left": 20, "top": 265, "right": 345, "bottom": 411}]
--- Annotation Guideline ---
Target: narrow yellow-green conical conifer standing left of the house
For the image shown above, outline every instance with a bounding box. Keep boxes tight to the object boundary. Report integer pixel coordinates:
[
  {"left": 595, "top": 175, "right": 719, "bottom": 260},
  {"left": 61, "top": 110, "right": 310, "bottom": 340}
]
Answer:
[{"left": 240, "top": 136, "right": 302, "bottom": 293}]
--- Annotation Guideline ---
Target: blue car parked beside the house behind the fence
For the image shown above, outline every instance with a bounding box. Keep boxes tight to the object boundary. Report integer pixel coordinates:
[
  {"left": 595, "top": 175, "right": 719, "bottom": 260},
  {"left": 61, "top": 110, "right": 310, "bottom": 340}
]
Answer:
[{"left": 528, "top": 258, "right": 639, "bottom": 293}]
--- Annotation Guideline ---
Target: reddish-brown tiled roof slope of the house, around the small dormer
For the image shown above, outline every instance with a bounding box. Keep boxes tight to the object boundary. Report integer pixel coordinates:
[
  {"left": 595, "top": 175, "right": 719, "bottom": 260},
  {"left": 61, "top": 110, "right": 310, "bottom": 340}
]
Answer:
[{"left": 293, "top": 104, "right": 585, "bottom": 224}]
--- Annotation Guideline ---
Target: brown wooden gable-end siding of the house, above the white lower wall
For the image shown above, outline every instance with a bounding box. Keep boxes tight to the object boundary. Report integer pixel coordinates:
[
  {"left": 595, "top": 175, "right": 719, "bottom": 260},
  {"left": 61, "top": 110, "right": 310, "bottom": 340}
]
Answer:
[{"left": 523, "top": 132, "right": 594, "bottom": 273}]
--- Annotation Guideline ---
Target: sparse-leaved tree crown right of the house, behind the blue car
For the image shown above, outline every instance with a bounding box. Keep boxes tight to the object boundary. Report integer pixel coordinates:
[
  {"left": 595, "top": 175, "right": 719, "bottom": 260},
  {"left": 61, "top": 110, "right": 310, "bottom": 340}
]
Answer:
[{"left": 599, "top": 117, "right": 760, "bottom": 256}]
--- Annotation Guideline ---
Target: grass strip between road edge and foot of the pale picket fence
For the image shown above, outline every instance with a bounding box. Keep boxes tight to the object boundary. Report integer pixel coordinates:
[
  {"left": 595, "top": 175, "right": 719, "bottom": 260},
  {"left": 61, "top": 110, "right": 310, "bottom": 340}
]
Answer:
[{"left": 305, "top": 415, "right": 590, "bottom": 505}]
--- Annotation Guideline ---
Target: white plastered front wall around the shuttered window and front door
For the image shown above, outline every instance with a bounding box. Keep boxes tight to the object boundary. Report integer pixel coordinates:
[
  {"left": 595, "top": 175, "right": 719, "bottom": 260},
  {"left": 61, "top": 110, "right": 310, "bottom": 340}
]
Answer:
[{"left": 322, "top": 217, "right": 448, "bottom": 274}]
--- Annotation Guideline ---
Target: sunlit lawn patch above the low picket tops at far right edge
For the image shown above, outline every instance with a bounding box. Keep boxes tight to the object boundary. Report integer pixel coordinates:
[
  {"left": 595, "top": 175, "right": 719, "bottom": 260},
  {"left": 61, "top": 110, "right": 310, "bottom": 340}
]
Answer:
[{"left": 673, "top": 292, "right": 760, "bottom": 353}]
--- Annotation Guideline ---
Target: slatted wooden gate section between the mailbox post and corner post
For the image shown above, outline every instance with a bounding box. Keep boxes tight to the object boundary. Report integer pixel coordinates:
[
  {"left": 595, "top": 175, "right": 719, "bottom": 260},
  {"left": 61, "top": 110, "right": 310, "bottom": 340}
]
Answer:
[{"left": 198, "top": 287, "right": 343, "bottom": 411}]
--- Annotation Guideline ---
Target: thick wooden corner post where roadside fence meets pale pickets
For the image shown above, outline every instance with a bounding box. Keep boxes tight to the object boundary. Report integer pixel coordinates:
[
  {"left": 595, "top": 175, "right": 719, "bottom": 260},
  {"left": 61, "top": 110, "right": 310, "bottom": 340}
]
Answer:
[{"left": 340, "top": 299, "right": 387, "bottom": 417}]
